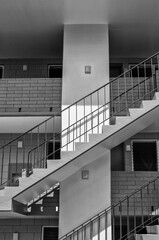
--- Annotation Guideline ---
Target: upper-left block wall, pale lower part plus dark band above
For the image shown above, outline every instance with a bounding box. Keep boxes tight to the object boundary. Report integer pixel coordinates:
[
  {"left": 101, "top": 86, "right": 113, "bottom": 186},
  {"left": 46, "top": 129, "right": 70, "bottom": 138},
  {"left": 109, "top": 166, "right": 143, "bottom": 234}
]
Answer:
[{"left": 0, "top": 58, "right": 62, "bottom": 113}]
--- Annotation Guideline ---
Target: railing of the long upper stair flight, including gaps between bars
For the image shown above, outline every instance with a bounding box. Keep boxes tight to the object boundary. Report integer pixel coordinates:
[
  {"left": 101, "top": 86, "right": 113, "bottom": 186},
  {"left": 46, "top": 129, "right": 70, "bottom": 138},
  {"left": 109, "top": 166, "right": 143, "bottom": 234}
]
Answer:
[{"left": 0, "top": 53, "right": 159, "bottom": 185}]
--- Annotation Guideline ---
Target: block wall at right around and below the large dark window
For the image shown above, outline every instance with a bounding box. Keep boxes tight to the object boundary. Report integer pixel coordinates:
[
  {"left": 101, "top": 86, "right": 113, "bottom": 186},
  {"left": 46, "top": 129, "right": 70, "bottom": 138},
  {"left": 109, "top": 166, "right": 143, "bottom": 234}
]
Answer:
[{"left": 111, "top": 132, "right": 159, "bottom": 217}]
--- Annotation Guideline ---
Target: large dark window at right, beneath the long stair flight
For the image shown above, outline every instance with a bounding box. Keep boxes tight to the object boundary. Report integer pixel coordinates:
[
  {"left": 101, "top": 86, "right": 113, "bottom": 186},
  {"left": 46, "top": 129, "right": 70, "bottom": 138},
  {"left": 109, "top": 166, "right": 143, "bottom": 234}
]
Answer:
[{"left": 132, "top": 141, "right": 157, "bottom": 171}]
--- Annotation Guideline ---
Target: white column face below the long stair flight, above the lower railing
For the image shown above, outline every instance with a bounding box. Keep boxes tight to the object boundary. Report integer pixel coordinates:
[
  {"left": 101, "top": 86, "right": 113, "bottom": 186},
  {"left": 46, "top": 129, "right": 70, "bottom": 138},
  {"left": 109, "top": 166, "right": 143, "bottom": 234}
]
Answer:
[{"left": 59, "top": 153, "right": 110, "bottom": 237}]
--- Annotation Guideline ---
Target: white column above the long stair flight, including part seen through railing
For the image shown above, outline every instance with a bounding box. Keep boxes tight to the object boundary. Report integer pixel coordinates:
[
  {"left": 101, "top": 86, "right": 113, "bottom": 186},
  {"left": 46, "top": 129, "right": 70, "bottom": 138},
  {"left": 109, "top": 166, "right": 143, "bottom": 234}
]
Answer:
[{"left": 62, "top": 24, "right": 109, "bottom": 150}]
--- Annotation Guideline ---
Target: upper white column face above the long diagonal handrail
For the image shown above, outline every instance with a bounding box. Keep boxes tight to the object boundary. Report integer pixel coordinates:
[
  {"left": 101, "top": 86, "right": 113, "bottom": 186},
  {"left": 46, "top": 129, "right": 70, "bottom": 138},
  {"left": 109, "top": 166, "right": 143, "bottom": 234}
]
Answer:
[{"left": 62, "top": 24, "right": 109, "bottom": 107}]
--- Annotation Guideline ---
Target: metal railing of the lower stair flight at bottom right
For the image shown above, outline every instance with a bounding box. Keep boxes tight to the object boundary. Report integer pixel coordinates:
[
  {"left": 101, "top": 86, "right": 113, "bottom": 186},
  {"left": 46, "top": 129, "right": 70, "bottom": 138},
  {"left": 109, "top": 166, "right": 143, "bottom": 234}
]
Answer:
[{"left": 60, "top": 176, "right": 159, "bottom": 240}]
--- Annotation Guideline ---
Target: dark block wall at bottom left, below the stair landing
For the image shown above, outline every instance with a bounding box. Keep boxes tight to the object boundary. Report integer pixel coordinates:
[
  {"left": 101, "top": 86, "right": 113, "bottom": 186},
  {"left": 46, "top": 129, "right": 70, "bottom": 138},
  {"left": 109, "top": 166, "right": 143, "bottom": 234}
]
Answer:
[{"left": 0, "top": 218, "right": 58, "bottom": 240}]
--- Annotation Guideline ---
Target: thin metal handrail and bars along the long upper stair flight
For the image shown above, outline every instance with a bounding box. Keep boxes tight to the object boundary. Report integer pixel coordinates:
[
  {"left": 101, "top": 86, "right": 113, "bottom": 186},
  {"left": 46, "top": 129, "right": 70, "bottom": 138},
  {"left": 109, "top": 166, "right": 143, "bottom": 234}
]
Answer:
[{"left": 0, "top": 53, "right": 159, "bottom": 188}]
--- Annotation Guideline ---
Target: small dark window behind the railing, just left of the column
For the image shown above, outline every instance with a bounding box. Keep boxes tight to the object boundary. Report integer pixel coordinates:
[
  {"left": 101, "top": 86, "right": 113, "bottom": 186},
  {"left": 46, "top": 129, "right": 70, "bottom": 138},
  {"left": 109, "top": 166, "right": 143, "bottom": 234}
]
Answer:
[{"left": 47, "top": 140, "right": 61, "bottom": 159}]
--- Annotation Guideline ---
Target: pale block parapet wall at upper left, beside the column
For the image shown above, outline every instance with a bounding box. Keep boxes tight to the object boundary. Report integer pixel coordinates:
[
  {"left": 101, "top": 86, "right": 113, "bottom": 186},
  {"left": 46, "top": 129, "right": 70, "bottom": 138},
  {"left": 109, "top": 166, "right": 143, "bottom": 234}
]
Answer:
[{"left": 0, "top": 78, "right": 62, "bottom": 114}]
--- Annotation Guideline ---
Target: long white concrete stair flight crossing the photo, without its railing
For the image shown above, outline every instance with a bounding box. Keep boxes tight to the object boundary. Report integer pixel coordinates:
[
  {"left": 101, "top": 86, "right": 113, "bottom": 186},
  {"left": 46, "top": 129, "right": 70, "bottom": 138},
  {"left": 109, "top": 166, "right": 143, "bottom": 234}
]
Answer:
[{"left": 0, "top": 93, "right": 159, "bottom": 211}]
